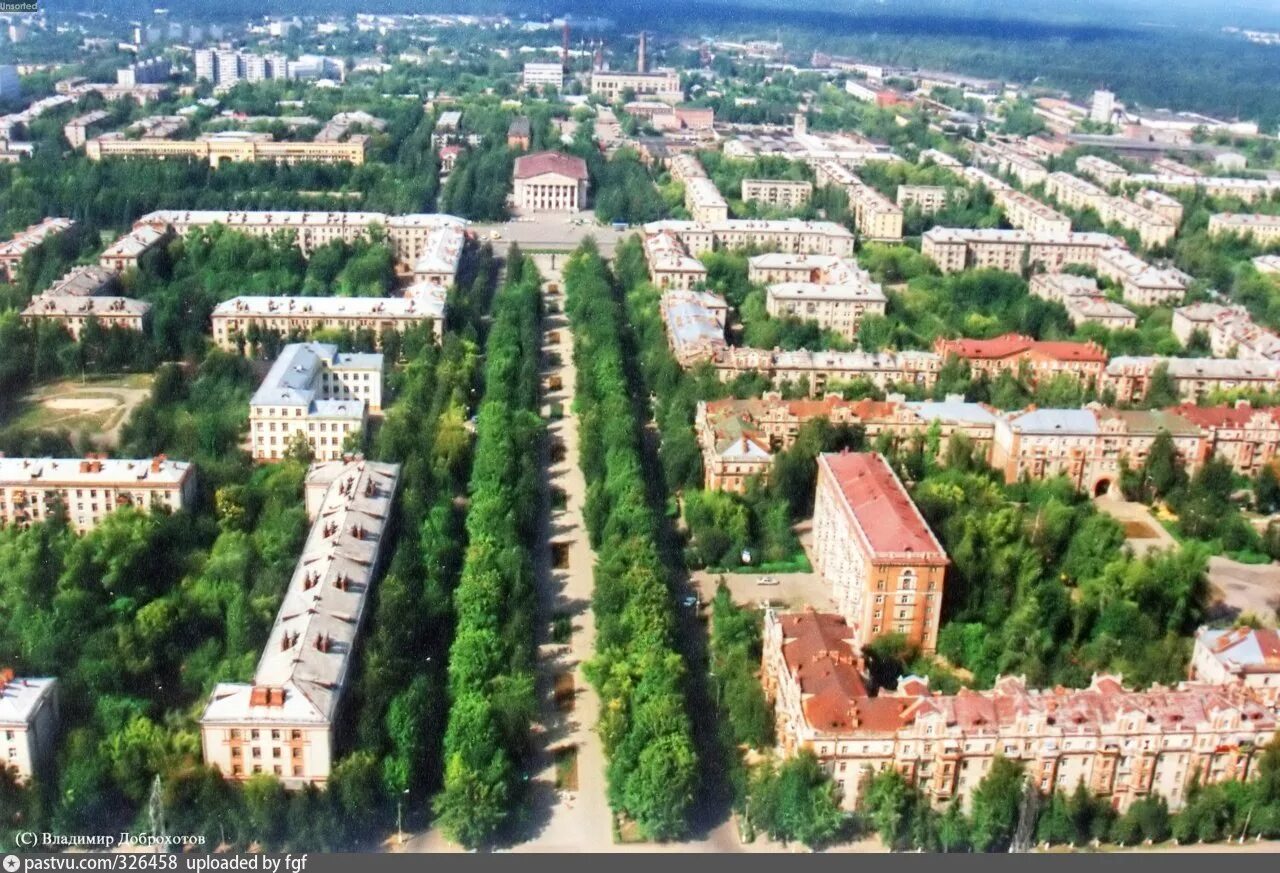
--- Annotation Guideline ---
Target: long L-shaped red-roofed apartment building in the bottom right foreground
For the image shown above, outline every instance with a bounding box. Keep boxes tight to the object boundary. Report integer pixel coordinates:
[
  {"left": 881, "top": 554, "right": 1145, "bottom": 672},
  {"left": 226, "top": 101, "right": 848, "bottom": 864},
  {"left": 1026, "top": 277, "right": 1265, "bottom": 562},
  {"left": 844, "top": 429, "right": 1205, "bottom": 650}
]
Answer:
[{"left": 762, "top": 619, "right": 1276, "bottom": 812}]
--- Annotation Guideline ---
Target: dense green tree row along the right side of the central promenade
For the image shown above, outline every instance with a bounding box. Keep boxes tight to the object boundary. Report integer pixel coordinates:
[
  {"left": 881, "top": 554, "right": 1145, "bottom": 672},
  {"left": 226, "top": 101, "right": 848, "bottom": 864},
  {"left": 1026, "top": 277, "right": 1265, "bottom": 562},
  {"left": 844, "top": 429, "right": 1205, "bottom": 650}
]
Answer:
[{"left": 564, "top": 242, "right": 699, "bottom": 840}]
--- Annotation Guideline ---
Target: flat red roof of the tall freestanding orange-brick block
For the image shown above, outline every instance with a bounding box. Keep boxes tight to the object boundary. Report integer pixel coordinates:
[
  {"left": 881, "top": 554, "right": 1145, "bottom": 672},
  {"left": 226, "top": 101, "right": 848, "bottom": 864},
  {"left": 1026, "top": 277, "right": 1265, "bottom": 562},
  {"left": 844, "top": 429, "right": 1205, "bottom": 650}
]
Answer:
[{"left": 818, "top": 452, "right": 947, "bottom": 565}]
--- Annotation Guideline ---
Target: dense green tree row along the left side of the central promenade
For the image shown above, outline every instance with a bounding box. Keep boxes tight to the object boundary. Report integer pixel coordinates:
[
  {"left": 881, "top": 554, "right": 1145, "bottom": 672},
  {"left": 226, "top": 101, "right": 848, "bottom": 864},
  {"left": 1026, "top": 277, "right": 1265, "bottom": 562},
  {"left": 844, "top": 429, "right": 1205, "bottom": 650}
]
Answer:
[{"left": 435, "top": 244, "right": 543, "bottom": 846}]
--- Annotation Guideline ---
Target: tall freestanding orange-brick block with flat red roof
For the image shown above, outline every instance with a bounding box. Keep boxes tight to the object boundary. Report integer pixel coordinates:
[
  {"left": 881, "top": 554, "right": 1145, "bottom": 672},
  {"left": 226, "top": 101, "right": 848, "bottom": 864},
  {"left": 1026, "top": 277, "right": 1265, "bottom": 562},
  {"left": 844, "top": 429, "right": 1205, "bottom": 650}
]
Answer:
[{"left": 813, "top": 452, "right": 950, "bottom": 652}]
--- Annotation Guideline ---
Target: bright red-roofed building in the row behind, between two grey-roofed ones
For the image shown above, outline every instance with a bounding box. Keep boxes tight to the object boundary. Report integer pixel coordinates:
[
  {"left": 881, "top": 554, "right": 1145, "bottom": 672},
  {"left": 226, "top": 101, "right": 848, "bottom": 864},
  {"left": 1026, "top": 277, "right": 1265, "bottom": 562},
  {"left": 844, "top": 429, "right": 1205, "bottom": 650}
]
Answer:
[{"left": 933, "top": 333, "right": 1107, "bottom": 385}]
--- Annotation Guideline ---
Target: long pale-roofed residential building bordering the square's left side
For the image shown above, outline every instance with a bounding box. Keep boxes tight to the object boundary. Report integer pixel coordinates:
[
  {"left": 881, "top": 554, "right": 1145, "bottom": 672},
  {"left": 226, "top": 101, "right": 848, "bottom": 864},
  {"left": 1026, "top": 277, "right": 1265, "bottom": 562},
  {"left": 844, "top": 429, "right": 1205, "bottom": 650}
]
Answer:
[{"left": 133, "top": 210, "right": 467, "bottom": 280}]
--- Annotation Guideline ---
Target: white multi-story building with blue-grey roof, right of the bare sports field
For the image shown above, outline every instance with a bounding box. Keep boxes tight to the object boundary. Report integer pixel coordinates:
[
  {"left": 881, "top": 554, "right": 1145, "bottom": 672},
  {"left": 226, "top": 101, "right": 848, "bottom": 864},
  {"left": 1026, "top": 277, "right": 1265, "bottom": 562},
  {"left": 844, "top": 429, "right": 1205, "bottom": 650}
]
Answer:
[{"left": 248, "top": 343, "right": 383, "bottom": 461}]
